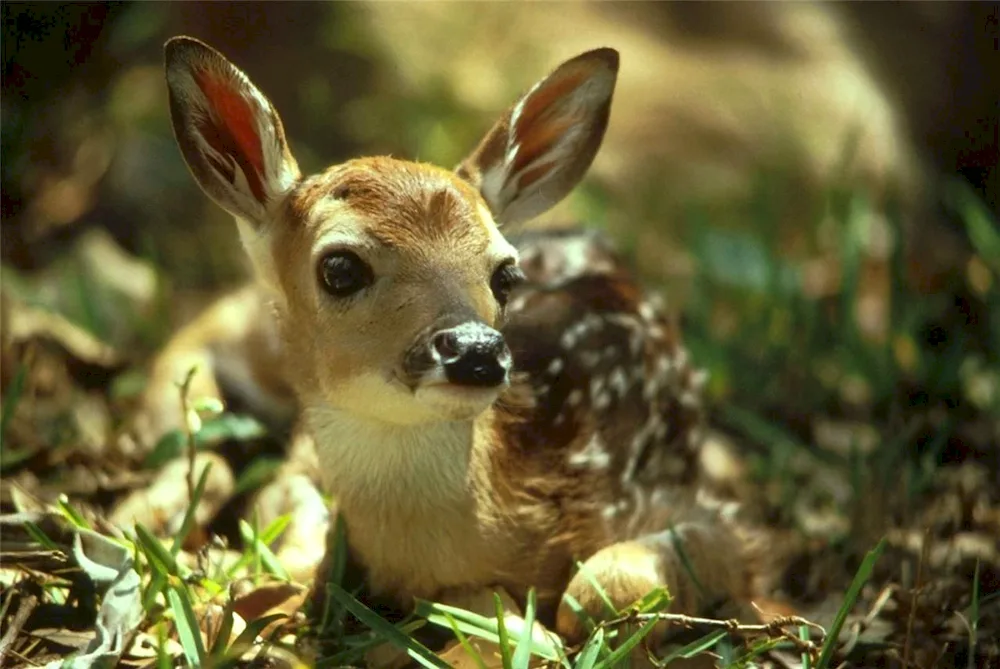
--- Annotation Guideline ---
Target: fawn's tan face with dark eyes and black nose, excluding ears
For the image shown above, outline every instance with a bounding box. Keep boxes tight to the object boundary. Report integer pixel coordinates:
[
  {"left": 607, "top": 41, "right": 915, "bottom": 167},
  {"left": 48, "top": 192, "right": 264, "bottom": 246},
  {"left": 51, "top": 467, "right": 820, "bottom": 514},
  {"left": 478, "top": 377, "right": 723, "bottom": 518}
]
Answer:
[{"left": 271, "top": 158, "right": 520, "bottom": 423}]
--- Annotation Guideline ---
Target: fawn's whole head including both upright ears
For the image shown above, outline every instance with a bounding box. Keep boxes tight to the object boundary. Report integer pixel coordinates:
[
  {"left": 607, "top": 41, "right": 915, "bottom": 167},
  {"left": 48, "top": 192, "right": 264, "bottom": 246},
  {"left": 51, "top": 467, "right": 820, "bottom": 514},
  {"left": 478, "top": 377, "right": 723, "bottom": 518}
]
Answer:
[{"left": 165, "top": 37, "right": 618, "bottom": 423}]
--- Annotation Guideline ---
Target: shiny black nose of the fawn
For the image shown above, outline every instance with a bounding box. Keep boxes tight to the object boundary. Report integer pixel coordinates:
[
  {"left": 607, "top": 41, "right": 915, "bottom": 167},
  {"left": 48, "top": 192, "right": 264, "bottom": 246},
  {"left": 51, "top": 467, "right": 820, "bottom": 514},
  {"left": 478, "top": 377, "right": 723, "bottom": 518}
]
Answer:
[{"left": 432, "top": 322, "right": 510, "bottom": 387}]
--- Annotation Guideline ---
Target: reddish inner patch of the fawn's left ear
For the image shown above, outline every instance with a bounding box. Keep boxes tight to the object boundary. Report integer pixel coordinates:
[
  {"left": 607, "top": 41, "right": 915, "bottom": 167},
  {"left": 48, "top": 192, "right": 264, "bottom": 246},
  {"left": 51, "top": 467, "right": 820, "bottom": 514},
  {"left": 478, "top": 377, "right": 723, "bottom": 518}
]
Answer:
[{"left": 196, "top": 70, "right": 265, "bottom": 202}]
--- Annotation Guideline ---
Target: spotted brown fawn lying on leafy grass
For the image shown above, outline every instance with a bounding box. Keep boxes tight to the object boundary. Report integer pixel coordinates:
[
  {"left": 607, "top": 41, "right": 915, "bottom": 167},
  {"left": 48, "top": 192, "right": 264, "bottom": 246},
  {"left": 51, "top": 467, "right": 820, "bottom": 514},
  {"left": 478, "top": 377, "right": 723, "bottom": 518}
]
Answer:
[{"left": 159, "top": 37, "right": 754, "bottom": 656}]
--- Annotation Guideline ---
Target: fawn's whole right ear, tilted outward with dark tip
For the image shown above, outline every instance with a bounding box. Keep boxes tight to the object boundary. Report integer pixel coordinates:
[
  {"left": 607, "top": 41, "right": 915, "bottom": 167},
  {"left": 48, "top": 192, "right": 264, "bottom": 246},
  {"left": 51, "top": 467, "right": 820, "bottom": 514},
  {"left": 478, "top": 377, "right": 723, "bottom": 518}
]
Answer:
[{"left": 457, "top": 49, "right": 618, "bottom": 224}]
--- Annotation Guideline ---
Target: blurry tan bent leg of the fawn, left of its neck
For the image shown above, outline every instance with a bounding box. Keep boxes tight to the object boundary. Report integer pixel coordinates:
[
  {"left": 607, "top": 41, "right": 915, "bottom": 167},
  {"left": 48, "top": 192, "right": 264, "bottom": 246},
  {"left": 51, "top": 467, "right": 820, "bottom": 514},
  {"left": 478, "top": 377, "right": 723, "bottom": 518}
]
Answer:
[{"left": 124, "top": 286, "right": 294, "bottom": 450}]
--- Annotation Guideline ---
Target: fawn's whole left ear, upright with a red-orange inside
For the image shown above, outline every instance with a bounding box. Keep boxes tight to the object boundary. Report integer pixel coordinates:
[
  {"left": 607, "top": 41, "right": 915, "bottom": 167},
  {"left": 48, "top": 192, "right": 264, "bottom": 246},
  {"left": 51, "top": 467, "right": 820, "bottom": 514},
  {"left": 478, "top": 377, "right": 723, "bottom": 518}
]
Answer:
[{"left": 164, "top": 37, "right": 300, "bottom": 226}]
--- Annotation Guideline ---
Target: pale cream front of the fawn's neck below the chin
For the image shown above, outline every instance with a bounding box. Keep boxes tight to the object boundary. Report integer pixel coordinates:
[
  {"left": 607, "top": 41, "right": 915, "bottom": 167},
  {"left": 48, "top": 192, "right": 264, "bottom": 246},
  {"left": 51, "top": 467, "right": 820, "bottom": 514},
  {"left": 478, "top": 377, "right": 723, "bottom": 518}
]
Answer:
[{"left": 305, "top": 408, "right": 511, "bottom": 601}]
